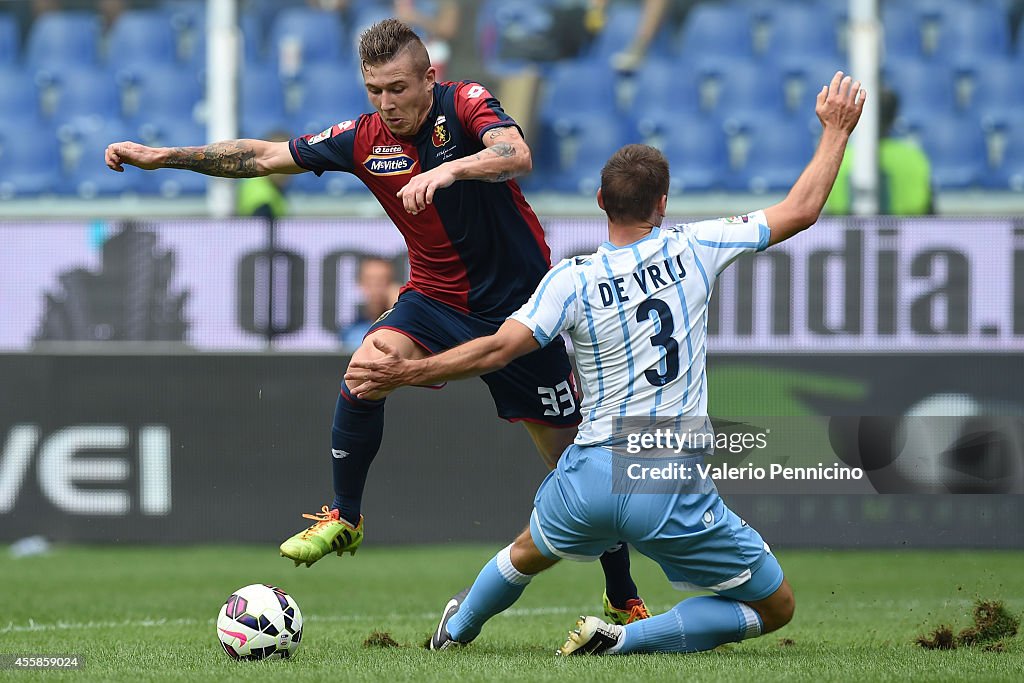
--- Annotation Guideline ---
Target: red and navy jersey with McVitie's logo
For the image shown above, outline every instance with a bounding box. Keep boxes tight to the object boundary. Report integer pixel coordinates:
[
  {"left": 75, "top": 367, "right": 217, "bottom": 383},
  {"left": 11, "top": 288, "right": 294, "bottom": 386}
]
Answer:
[{"left": 290, "top": 82, "right": 551, "bottom": 321}]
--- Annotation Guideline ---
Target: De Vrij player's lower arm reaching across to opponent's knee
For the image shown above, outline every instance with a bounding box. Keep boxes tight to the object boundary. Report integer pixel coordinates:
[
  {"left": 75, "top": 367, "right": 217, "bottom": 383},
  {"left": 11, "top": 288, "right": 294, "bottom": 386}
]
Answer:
[{"left": 345, "top": 321, "right": 540, "bottom": 397}]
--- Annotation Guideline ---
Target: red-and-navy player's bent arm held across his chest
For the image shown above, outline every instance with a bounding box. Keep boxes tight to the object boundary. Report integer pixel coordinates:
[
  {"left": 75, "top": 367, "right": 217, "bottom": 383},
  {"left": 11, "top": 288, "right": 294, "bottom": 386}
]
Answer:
[{"left": 398, "top": 126, "right": 534, "bottom": 214}]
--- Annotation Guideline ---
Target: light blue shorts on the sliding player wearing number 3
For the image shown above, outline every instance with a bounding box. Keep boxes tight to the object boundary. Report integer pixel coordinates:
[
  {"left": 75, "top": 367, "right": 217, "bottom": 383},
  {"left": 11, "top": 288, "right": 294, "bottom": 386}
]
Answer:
[{"left": 529, "top": 444, "right": 782, "bottom": 601}]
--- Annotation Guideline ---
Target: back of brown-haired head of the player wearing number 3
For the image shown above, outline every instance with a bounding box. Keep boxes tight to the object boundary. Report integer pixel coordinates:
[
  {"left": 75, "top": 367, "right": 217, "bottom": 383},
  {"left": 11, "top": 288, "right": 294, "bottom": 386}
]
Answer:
[{"left": 601, "top": 144, "right": 669, "bottom": 223}]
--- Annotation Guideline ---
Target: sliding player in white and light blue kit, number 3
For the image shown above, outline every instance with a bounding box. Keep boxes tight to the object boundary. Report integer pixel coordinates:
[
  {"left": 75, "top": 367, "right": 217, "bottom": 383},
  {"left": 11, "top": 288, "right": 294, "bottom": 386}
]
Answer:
[{"left": 346, "top": 72, "right": 865, "bottom": 654}]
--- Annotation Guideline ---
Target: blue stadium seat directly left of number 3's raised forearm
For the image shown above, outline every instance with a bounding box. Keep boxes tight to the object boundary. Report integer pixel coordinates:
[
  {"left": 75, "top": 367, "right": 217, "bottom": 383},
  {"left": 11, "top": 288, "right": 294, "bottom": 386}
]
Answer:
[{"left": 726, "top": 118, "right": 815, "bottom": 193}]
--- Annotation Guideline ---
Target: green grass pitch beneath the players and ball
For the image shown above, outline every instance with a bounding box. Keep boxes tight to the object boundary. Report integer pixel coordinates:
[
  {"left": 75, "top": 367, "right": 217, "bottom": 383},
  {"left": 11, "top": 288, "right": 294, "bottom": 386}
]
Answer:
[{"left": 0, "top": 545, "right": 1024, "bottom": 683}]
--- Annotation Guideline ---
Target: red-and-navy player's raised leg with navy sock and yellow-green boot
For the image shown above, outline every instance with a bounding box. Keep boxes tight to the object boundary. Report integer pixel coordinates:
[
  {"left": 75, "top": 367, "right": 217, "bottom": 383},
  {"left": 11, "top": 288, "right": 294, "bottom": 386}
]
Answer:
[{"left": 281, "top": 328, "right": 427, "bottom": 566}]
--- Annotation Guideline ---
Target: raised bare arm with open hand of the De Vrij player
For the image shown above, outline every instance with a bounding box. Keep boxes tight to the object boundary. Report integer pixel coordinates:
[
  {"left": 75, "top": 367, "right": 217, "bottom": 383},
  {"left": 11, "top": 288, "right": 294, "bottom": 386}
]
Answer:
[{"left": 765, "top": 72, "right": 867, "bottom": 245}]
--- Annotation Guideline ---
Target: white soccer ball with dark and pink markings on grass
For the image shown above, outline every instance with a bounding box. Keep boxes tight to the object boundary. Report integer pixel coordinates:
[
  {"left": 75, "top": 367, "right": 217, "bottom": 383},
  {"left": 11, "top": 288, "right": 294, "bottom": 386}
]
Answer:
[{"left": 217, "top": 584, "right": 302, "bottom": 659}]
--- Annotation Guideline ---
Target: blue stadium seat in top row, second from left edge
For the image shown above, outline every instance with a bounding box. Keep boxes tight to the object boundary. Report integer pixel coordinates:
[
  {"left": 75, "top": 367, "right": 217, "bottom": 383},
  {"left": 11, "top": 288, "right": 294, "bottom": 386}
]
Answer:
[{"left": 26, "top": 11, "right": 99, "bottom": 69}]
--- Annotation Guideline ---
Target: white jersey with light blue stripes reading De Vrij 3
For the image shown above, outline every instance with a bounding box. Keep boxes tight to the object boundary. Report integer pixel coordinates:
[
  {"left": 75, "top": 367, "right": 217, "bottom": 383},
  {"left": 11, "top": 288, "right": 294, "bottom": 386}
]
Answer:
[{"left": 511, "top": 211, "right": 770, "bottom": 445}]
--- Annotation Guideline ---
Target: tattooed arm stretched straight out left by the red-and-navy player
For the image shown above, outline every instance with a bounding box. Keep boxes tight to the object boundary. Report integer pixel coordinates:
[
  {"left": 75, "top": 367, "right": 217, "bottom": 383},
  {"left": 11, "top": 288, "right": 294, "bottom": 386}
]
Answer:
[{"left": 106, "top": 139, "right": 305, "bottom": 178}]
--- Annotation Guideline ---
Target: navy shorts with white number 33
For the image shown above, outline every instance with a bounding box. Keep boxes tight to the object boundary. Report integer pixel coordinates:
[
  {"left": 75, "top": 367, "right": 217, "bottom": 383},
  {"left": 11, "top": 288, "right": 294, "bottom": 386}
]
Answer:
[{"left": 367, "top": 291, "right": 581, "bottom": 427}]
